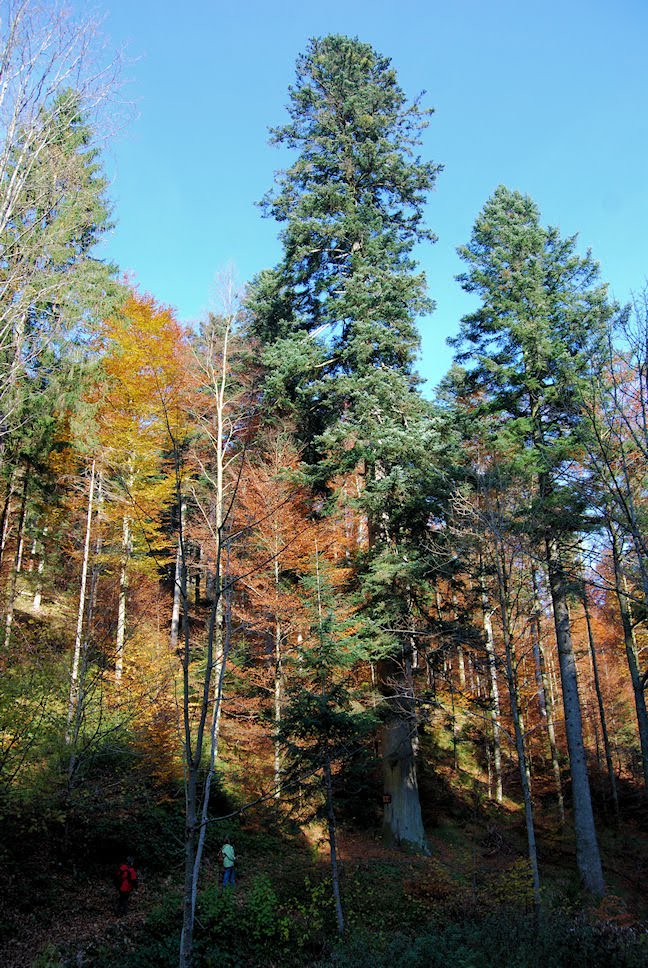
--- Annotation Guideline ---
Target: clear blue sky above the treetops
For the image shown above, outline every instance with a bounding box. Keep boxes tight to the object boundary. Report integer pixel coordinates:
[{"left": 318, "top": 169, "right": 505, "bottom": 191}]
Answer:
[{"left": 90, "top": 0, "right": 648, "bottom": 392}]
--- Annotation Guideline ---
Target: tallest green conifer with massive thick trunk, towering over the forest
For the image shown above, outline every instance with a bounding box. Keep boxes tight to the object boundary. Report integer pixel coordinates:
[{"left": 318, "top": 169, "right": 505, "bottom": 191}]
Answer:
[{"left": 249, "top": 35, "right": 439, "bottom": 847}]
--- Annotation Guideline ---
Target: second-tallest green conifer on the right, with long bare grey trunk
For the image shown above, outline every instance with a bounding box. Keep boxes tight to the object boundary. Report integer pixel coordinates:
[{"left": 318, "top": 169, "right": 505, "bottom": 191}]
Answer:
[{"left": 452, "top": 186, "right": 614, "bottom": 894}]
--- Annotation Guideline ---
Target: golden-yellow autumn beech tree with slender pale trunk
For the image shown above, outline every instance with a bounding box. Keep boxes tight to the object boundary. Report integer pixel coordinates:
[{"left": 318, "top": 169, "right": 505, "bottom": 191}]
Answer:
[{"left": 94, "top": 293, "right": 189, "bottom": 684}]
